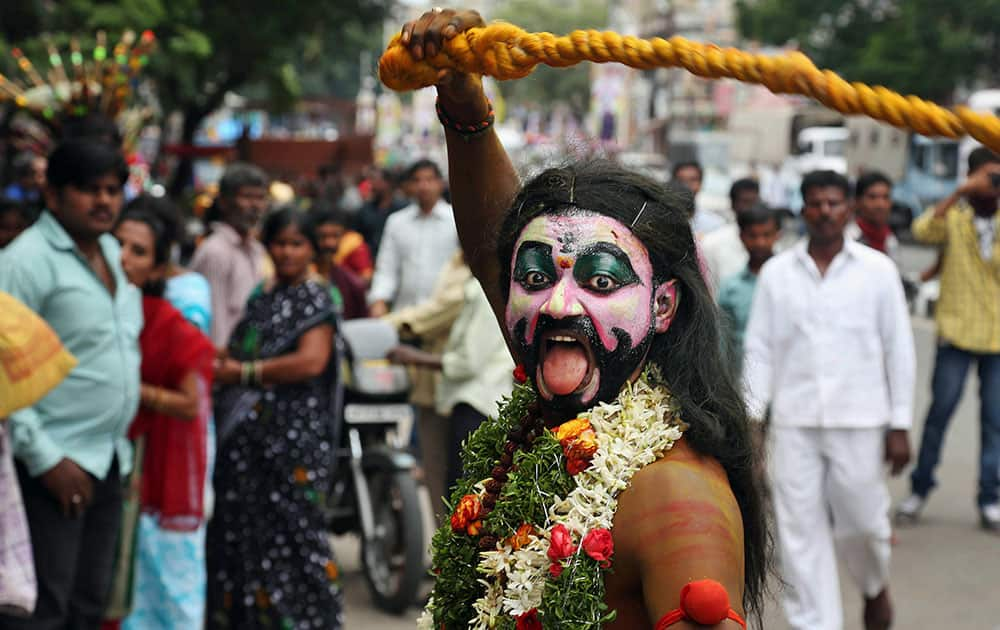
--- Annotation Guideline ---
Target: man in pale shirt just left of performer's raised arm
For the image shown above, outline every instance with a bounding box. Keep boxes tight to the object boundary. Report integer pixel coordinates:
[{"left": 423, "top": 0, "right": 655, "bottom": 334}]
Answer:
[{"left": 368, "top": 160, "right": 458, "bottom": 317}]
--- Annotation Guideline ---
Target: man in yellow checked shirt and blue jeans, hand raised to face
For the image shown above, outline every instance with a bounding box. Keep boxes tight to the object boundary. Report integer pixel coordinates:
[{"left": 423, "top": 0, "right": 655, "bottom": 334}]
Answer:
[{"left": 896, "top": 147, "right": 1000, "bottom": 532}]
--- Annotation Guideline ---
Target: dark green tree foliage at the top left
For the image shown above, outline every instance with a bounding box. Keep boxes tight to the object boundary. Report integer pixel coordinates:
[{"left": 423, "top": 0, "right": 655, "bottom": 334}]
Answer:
[{"left": 0, "top": 0, "right": 390, "bottom": 140}]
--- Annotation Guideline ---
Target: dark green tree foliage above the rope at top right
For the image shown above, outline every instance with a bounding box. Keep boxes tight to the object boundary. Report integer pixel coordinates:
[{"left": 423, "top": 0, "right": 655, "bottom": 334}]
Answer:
[{"left": 737, "top": 0, "right": 1000, "bottom": 101}]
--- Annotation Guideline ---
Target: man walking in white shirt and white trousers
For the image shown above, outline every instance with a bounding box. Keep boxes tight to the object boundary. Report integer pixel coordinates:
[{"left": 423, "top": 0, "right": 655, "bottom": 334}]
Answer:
[{"left": 744, "top": 171, "right": 915, "bottom": 630}]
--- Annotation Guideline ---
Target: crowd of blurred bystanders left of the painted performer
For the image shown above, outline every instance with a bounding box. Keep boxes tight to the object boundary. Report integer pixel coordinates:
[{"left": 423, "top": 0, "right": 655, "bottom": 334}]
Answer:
[{"left": 0, "top": 116, "right": 513, "bottom": 629}]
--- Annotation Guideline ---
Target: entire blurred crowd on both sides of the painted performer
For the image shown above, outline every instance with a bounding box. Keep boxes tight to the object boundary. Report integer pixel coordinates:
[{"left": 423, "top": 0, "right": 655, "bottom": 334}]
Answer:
[{"left": 0, "top": 81, "right": 1000, "bottom": 630}]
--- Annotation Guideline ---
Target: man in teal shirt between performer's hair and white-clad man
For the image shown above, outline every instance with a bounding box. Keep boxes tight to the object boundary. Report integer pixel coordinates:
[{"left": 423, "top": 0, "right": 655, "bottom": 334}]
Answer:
[{"left": 718, "top": 206, "right": 781, "bottom": 371}]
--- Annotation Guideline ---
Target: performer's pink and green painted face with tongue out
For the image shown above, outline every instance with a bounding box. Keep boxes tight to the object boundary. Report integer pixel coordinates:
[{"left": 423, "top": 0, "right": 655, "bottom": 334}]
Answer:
[{"left": 506, "top": 210, "right": 676, "bottom": 413}]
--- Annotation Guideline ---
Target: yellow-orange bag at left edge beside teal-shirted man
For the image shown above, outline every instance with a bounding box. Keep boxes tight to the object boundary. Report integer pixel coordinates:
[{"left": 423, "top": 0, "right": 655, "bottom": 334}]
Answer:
[{"left": 0, "top": 291, "right": 76, "bottom": 419}]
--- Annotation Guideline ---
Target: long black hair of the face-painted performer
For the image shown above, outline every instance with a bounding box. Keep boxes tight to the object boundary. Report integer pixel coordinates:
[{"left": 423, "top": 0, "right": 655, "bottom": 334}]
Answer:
[{"left": 497, "top": 160, "right": 773, "bottom": 619}]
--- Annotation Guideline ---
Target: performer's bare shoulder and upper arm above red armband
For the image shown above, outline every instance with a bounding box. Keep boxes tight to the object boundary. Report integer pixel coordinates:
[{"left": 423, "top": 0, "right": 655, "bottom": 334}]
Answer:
[{"left": 613, "top": 440, "right": 744, "bottom": 619}]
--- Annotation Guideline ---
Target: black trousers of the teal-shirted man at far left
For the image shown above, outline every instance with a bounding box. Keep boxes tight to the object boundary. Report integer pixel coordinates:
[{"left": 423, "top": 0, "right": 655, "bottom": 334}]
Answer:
[{"left": 0, "top": 460, "right": 122, "bottom": 630}]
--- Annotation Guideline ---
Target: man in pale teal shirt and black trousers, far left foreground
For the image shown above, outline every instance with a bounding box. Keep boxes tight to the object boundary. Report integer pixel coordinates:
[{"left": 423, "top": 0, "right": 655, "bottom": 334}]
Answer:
[{"left": 0, "top": 140, "right": 143, "bottom": 630}]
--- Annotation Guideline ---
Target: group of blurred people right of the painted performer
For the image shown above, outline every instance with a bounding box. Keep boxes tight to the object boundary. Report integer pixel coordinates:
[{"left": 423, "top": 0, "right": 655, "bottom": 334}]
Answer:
[{"left": 674, "top": 147, "right": 1000, "bottom": 630}]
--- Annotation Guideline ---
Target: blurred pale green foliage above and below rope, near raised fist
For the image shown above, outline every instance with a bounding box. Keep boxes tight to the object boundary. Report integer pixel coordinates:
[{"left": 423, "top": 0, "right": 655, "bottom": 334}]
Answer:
[{"left": 494, "top": 0, "right": 608, "bottom": 115}]
